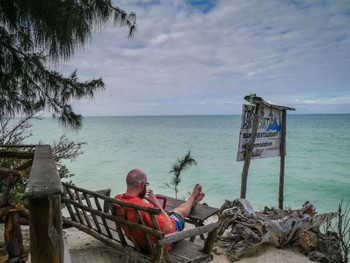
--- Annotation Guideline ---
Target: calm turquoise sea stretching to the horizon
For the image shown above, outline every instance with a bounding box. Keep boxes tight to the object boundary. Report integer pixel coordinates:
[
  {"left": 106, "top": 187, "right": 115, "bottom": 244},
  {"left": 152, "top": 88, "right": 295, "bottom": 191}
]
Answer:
[{"left": 26, "top": 114, "right": 350, "bottom": 213}]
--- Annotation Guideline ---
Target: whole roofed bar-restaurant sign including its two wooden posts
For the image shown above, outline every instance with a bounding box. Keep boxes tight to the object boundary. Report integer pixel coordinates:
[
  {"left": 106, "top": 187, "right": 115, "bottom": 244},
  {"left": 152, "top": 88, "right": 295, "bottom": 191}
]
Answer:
[{"left": 237, "top": 94, "right": 295, "bottom": 209}]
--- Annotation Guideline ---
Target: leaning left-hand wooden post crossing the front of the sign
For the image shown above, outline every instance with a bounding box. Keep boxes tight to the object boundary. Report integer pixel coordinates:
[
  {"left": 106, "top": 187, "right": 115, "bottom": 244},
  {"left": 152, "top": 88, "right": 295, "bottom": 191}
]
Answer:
[{"left": 241, "top": 104, "right": 260, "bottom": 199}]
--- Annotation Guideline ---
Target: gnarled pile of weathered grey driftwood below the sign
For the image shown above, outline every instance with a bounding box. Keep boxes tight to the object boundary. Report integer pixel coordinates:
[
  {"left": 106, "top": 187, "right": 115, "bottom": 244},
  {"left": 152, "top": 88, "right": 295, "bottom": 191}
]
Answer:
[{"left": 217, "top": 199, "right": 336, "bottom": 261}]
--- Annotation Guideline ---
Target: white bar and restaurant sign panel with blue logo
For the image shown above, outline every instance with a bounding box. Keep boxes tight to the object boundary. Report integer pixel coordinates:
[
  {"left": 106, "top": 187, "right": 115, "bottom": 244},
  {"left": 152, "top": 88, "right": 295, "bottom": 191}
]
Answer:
[{"left": 237, "top": 105, "right": 282, "bottom": 161}]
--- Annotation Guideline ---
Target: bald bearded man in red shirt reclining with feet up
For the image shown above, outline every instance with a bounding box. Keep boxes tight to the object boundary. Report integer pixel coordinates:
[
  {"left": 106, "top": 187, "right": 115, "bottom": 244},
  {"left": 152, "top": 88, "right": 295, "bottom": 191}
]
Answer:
[{"left": 115, "top": 169, "right": 204, "bottom": 250}]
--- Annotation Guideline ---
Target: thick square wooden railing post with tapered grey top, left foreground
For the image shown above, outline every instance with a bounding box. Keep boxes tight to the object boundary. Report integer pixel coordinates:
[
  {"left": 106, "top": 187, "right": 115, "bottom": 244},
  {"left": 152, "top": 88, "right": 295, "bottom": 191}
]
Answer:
[{"left": 24, "top": 145, "right": 64, "bottom": 263}]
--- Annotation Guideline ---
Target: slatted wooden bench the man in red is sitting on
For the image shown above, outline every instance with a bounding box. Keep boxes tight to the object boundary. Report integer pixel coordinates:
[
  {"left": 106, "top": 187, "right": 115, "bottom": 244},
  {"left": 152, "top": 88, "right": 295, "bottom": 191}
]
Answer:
[{"left": 61, "top": 183, "right": 219, "bottom": 262}]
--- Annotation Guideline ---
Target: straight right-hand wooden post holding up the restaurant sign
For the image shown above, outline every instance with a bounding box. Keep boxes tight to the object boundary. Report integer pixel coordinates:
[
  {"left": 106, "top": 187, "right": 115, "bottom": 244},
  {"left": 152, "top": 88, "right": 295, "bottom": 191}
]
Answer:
[{"left": 278, "top": 109, "right": 287, "bottom": 209}]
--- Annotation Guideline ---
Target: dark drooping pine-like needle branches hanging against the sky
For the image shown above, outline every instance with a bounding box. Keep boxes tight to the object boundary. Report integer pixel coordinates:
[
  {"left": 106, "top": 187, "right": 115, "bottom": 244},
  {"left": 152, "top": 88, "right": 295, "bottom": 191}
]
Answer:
[{"left": 0, "top": 0, "right": 136, "bottom": 128}]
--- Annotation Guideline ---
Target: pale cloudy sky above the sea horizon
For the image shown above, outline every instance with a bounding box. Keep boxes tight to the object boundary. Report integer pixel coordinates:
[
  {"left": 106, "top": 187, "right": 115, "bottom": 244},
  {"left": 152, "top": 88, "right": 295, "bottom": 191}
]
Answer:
[{"left": 59, "top": 0, "right": 350, "bottom": 116}]
